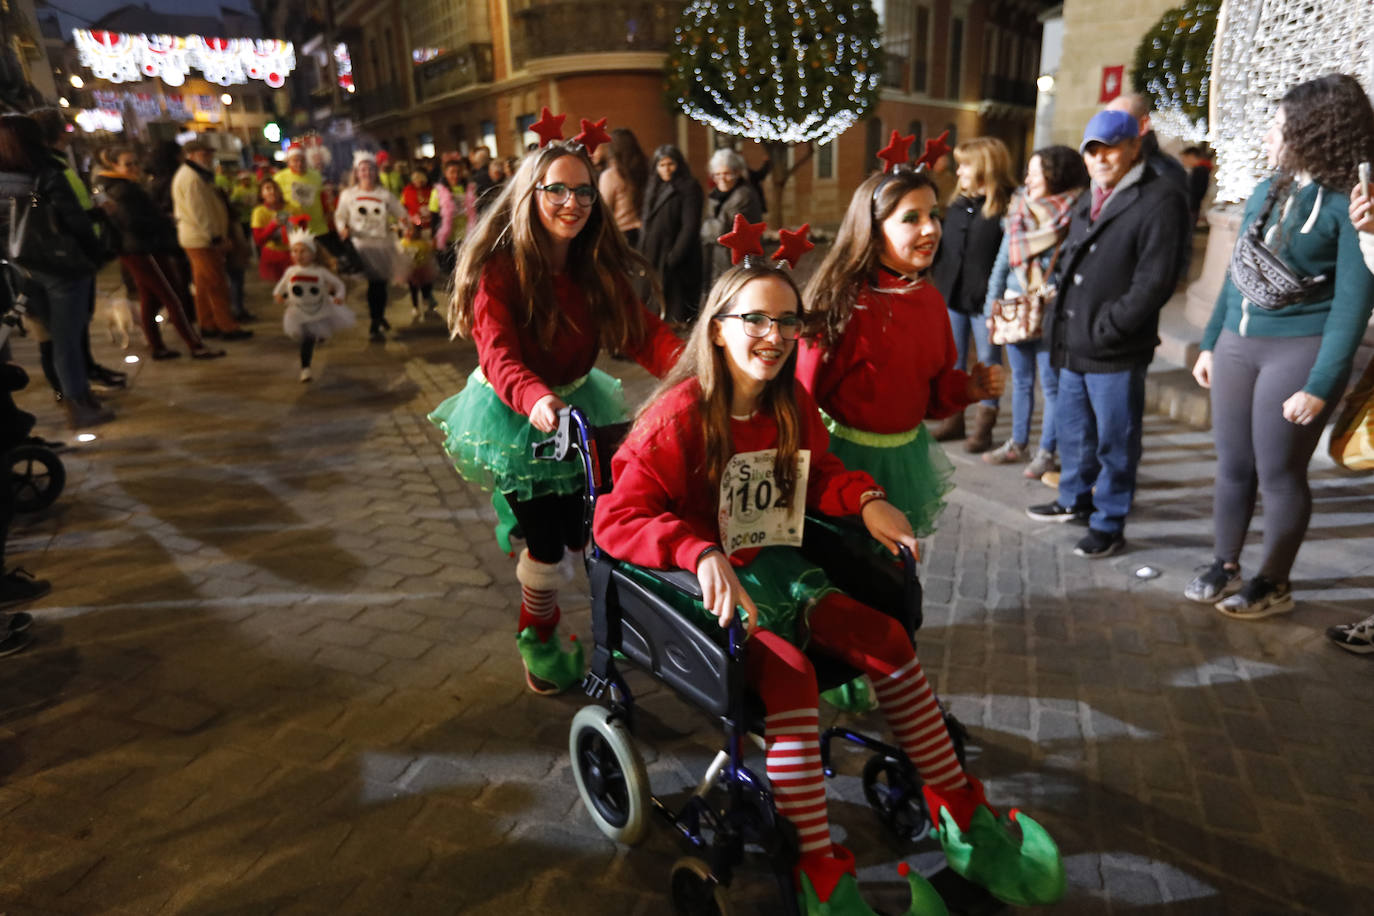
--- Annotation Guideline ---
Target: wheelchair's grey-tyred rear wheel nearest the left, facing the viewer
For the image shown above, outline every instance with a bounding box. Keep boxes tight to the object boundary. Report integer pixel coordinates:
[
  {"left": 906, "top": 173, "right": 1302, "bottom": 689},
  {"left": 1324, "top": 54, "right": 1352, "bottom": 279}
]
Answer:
[{"left": 567, "top": 706, "right": 649, "bottom": 845}]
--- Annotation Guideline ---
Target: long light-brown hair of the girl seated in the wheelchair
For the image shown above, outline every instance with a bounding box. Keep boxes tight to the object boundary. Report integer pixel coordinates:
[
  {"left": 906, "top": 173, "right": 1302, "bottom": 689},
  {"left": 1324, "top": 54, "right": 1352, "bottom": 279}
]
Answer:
[{"left": 632, "top": 261, "right": 801, "bottom": 503}]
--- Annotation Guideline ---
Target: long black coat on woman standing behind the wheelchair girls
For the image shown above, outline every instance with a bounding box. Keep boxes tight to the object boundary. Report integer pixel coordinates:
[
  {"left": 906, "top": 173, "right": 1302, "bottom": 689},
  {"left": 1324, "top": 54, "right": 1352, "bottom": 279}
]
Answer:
[{"left": 639, "top": 162, "right": 702, "bottom": 321}]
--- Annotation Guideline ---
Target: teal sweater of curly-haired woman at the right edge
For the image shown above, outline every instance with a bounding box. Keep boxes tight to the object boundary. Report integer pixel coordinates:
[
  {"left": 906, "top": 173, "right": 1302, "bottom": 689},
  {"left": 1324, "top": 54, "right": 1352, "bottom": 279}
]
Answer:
[{"left": 1201, "top": 179, "right": 1374, "bottom": 401}]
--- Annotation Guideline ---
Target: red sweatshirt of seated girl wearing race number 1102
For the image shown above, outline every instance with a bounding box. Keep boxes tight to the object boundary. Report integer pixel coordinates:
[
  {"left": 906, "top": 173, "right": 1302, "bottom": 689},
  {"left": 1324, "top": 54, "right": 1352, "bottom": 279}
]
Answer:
[{"left": 592, "top": 379, "right": 879, "bottom": 573}]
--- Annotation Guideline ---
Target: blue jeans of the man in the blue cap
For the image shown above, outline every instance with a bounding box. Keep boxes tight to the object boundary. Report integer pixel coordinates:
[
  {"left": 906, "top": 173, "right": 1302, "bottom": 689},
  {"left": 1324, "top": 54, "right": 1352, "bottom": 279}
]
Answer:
[{"left": 1055, "top": 365, "right": 1146, "bottom": 534}]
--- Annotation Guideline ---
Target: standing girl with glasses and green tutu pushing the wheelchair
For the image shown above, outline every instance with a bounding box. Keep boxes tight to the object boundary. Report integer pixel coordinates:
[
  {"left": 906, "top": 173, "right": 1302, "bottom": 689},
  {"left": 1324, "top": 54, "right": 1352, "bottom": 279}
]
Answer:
[{"left": 430, "top": 143, "right": 682, "bottom": 694}]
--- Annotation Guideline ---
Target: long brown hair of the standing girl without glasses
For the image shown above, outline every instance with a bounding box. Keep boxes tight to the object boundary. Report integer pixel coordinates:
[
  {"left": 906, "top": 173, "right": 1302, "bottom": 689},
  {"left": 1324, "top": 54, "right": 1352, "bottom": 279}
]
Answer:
[{"left": 805, "top": 169, "right": 940, "bottom": 347}]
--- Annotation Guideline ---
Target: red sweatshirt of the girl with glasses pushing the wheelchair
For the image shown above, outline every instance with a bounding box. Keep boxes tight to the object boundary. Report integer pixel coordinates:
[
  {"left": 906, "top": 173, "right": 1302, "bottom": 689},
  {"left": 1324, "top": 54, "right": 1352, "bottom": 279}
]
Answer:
[{"left": 473, "top": 255, "right": 683, "bottom": 416}]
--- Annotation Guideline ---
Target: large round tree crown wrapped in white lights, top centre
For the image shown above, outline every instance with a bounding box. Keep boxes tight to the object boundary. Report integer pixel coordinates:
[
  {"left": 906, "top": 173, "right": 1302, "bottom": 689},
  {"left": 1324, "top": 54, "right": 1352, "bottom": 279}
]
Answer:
[{"left": 668, "top": 0, "right": 882, "bottom": 143}]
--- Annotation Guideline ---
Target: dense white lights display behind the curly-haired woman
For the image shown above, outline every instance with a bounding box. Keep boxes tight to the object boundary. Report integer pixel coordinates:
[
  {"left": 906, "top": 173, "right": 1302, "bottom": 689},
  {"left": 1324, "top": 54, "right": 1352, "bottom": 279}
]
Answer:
[{"left": 1208, "top": 0, "right": 1374, "bottom": 203}]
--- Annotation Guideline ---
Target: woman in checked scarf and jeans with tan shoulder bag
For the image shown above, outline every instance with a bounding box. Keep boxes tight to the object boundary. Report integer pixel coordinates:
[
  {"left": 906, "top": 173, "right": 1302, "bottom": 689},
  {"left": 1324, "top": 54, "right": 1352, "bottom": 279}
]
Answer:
[{"left": 982, "top": 146, "right": 1088, "bottom": 479}]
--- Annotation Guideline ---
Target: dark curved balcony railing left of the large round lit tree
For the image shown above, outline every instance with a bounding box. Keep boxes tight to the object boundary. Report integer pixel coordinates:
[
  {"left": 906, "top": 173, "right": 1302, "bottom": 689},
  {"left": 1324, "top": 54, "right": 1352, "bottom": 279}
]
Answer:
[{"left": 511, "top": 0, "right": 686, "bottom": 67}]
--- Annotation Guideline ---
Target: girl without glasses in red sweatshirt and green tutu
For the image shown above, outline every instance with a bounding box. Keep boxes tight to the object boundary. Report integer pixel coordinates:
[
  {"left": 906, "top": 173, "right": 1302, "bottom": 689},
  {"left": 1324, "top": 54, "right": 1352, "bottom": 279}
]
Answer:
[{"left": 797, "top": 169, "right": 1002, "bottom": 537}]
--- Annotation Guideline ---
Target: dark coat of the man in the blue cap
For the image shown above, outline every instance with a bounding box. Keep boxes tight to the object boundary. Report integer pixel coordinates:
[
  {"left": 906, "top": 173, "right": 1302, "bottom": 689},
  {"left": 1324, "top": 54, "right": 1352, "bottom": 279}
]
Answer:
[{"left": 1046, "top": 165, "right": 1191, "bottom": 372}]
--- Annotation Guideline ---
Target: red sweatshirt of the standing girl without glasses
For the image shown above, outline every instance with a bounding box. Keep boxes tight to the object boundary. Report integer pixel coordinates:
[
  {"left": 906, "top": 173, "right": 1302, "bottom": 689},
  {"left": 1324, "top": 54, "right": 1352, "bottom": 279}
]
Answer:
[{"left": 797, "top": 271, "right": 981, "bottom": 434}]
